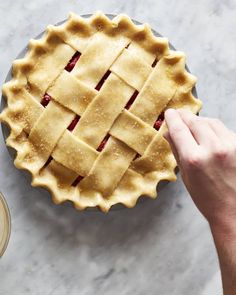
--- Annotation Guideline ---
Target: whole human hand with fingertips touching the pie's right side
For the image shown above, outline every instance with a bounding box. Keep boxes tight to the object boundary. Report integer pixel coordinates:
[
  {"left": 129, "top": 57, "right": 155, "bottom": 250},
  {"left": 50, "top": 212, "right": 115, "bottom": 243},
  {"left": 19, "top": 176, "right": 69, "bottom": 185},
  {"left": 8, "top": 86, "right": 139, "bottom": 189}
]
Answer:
[{"left": 164, "top": 109, "right": 236, "bottom": 230}]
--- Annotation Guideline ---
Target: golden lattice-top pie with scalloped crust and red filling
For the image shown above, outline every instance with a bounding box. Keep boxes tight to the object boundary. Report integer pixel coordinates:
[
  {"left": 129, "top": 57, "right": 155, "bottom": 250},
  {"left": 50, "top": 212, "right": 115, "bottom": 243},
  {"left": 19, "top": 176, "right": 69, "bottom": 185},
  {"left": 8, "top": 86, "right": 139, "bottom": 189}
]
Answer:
[{"left": 0, "top": 12, "right": 202, "bottom": 212}]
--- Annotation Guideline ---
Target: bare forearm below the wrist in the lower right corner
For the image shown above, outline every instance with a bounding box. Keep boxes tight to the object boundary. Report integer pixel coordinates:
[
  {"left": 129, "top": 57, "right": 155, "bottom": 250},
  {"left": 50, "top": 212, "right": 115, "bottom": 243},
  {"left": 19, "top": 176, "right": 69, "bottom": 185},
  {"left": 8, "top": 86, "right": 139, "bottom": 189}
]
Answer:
[{"left": 211, "top": 221, "right": 236, "bottom": 295}]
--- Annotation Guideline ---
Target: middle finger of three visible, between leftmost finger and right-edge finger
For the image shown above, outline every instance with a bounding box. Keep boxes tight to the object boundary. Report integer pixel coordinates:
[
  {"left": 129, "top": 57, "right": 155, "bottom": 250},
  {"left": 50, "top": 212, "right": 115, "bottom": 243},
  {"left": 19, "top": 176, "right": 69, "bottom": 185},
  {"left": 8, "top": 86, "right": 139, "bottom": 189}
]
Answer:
[{"left": 178, "top": 109, "right": 219, "bottom": 147}]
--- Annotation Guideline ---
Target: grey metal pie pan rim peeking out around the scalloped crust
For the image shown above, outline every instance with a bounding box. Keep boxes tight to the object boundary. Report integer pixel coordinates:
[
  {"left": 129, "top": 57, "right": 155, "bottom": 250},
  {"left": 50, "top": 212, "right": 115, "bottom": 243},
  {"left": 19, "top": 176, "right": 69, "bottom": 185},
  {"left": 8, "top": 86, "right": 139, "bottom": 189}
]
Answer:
[{"left": 0, "top": 14, "right": 197, "bottom": 211}]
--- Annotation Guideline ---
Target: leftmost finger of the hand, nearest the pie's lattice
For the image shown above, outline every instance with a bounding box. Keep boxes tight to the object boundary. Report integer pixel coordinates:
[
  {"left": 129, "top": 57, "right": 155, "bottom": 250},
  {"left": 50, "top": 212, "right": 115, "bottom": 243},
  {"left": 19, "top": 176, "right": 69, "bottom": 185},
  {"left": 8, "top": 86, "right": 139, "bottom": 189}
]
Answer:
[{"left": 165, "top": 109, "right": 197, "bottom": 157}]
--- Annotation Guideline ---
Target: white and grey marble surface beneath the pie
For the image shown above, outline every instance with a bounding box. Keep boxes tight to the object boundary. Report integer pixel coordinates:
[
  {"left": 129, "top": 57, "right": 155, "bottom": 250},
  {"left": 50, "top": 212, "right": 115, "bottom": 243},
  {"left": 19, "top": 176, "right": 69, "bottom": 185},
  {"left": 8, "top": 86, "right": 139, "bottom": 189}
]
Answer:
[{"left": 0, "top": 0, "right": 236, "bottom": 295}]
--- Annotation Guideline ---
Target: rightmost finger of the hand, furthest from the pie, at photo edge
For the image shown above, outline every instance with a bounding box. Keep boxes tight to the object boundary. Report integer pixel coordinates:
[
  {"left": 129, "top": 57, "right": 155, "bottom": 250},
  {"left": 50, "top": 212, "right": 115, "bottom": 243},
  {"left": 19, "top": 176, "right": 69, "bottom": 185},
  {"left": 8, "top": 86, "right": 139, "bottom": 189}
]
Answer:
[{"left": 203, "top": 118, "right": 235, "bottom": 142}]
